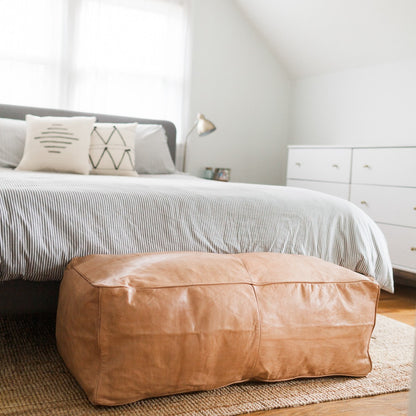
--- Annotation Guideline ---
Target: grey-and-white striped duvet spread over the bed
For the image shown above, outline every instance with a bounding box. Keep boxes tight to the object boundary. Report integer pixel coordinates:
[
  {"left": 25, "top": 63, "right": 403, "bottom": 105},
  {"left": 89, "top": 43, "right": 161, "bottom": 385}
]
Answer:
[{"left": 0, "top": 169, "right": 393, "bottom": 291}]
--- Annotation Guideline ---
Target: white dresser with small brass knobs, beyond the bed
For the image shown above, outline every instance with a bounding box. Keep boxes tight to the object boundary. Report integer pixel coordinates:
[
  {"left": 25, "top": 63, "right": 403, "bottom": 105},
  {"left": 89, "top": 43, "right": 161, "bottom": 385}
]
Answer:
[{"left": 287, "top": 146, "right": 416, "bottom": 273}]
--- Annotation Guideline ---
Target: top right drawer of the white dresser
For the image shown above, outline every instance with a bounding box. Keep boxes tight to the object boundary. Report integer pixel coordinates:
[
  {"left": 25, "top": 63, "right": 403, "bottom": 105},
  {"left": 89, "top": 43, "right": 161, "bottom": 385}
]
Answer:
[{"left": 352, "top": 147, "right": 416, "bottom": 186}]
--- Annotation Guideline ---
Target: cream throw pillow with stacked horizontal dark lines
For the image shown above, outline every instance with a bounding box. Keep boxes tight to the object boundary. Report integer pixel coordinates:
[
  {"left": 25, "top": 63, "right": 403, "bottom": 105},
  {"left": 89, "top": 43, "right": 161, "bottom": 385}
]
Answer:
[{"left": 16, "top": 115, "right": 95, "bottom": 175}]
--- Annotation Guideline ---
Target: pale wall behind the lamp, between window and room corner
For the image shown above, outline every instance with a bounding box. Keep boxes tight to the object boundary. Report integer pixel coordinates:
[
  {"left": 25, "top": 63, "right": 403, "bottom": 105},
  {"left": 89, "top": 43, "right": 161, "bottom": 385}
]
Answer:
[{"left": 184, "top": 0, "right": 290, "bottom": 184}]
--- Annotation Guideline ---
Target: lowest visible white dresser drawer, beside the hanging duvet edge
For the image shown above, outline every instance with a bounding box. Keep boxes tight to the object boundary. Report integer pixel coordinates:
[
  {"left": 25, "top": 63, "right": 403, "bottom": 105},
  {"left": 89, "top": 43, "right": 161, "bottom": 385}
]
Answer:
[{"left": 379, "top": 224, "right": 416, "bottom": 272}]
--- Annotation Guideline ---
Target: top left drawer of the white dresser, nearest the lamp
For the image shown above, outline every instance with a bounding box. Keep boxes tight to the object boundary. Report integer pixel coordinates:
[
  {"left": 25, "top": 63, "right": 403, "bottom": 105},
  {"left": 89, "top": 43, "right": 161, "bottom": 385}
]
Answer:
[{"left": 287, "top": 148, "right": 352, "bottom": 183}]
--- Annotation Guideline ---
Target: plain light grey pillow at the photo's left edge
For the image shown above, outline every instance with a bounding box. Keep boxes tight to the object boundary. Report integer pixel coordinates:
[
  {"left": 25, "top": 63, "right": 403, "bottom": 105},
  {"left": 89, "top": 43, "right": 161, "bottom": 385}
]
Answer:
[{"left": 0, "top": 118, "right": 26, "bottom": 168}]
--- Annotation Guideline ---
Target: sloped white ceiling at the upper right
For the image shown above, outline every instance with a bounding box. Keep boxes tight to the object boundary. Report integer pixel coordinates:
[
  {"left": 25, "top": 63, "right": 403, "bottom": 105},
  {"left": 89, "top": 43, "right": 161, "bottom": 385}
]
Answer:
[{"left": 236, "top": 0, "right": 416, "bottom": 78}]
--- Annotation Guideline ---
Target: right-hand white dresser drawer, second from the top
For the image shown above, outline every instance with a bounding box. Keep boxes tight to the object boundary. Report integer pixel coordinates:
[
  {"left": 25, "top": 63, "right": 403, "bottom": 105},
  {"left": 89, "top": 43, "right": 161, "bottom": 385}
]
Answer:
[{"left": 350, "top": 184, "right": 416, "bottom": 227}]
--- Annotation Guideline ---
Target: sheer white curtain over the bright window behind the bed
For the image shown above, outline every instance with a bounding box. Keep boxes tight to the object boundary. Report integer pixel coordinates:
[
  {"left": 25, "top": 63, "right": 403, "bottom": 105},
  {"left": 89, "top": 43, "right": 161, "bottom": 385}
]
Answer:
[{"left": 0, "top": 0, "right": 187, "bottom": 136}]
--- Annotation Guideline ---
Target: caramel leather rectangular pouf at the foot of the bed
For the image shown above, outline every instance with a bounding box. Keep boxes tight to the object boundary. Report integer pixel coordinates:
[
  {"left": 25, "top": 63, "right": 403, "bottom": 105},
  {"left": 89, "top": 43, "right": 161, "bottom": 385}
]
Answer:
[{"left": 56, "top": 252, "right": 379, "bottom": 405}]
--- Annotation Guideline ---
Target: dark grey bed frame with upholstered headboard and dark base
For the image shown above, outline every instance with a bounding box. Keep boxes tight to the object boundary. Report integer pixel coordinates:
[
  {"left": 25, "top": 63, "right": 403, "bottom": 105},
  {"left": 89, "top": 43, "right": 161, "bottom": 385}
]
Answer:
[{"left": 0, "top": 104, "right": 176, "bottom": 314}]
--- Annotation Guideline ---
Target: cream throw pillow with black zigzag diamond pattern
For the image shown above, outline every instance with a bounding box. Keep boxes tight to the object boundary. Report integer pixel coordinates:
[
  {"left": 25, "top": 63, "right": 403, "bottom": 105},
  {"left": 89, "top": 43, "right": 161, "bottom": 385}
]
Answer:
[{"left": 89, "top": 123, "right": 137, "bottom": 176}]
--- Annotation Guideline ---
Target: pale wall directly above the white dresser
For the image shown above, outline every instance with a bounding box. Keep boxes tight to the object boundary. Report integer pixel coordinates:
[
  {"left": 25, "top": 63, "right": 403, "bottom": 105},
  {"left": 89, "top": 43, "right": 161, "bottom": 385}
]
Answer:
[{"left": 289, "top": 59, "right": 416, "bottom": 145}]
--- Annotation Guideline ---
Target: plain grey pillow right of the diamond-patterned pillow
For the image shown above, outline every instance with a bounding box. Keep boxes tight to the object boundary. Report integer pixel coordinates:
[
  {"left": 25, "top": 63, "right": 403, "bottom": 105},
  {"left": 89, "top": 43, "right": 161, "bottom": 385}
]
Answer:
[{"left": 136, "top": 124, "right": 175, "bottom": 174}]
